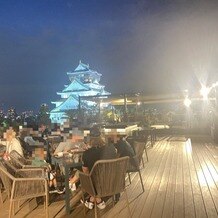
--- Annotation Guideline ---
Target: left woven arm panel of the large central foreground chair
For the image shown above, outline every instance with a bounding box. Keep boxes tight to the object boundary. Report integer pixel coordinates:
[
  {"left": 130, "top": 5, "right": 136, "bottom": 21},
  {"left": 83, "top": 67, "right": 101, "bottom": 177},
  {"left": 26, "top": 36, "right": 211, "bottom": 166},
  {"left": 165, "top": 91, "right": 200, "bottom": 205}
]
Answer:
[{"left": 79, "top": 172, "right": 96, "bottom": 196}]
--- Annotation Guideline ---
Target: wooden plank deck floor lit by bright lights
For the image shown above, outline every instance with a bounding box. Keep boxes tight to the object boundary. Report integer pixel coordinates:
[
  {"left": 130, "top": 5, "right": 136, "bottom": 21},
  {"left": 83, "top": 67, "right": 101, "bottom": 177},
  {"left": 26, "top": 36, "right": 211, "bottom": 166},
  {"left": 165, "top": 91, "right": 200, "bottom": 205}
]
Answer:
[{"left": 0, "top": 136, "right": 218, "bottom": 218}]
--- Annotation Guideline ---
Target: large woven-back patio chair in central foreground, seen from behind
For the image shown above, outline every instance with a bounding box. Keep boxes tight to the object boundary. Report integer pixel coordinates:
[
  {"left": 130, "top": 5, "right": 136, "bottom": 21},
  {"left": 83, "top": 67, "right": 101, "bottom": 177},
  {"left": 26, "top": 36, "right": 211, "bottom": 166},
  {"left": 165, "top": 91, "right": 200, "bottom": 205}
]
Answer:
[{"left": 79, "top": 157, "right": 131, "bottom": 217}]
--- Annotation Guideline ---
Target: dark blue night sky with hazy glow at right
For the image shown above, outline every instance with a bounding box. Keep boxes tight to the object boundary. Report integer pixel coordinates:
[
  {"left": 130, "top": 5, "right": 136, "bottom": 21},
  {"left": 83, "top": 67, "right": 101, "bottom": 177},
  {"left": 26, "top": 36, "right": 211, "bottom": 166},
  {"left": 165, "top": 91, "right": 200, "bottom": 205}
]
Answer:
[{"left": 0, "top": 0, "right": 218, "bottom": 112}]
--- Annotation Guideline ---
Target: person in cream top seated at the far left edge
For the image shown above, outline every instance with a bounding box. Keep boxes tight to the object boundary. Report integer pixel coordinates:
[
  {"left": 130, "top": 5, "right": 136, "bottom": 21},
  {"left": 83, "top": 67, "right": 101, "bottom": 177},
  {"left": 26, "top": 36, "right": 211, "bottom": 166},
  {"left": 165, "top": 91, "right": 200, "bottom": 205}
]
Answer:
[{"left": 1, "top": 127, "right": 23, "bottom": 159}]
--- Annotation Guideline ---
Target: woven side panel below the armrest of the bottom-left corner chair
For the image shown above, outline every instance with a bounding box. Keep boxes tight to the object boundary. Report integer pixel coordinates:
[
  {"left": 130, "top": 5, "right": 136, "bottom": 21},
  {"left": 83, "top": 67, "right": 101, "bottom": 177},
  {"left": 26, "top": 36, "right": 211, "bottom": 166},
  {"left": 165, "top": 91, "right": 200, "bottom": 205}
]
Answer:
[{"left": 12, "top": 178, "right": 48, "bottom": 199}]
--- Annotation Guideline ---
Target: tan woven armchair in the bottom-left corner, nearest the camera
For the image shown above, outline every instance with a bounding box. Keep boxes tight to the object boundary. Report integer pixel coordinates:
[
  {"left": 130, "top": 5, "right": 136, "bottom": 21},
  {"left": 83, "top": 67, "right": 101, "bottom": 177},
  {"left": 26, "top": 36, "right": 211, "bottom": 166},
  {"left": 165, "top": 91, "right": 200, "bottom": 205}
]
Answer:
[{"left": 0, "top": 162, "right": 48, "bottom": 218}]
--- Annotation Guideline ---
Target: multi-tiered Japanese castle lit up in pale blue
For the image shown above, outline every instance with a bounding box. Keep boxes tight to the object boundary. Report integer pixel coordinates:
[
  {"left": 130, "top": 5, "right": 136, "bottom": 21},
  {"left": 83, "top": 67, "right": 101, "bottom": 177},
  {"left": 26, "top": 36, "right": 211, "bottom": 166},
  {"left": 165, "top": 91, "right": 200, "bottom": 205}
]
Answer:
[{"left": 50, "top": 61, "right": 110, "bottom": 124}]
